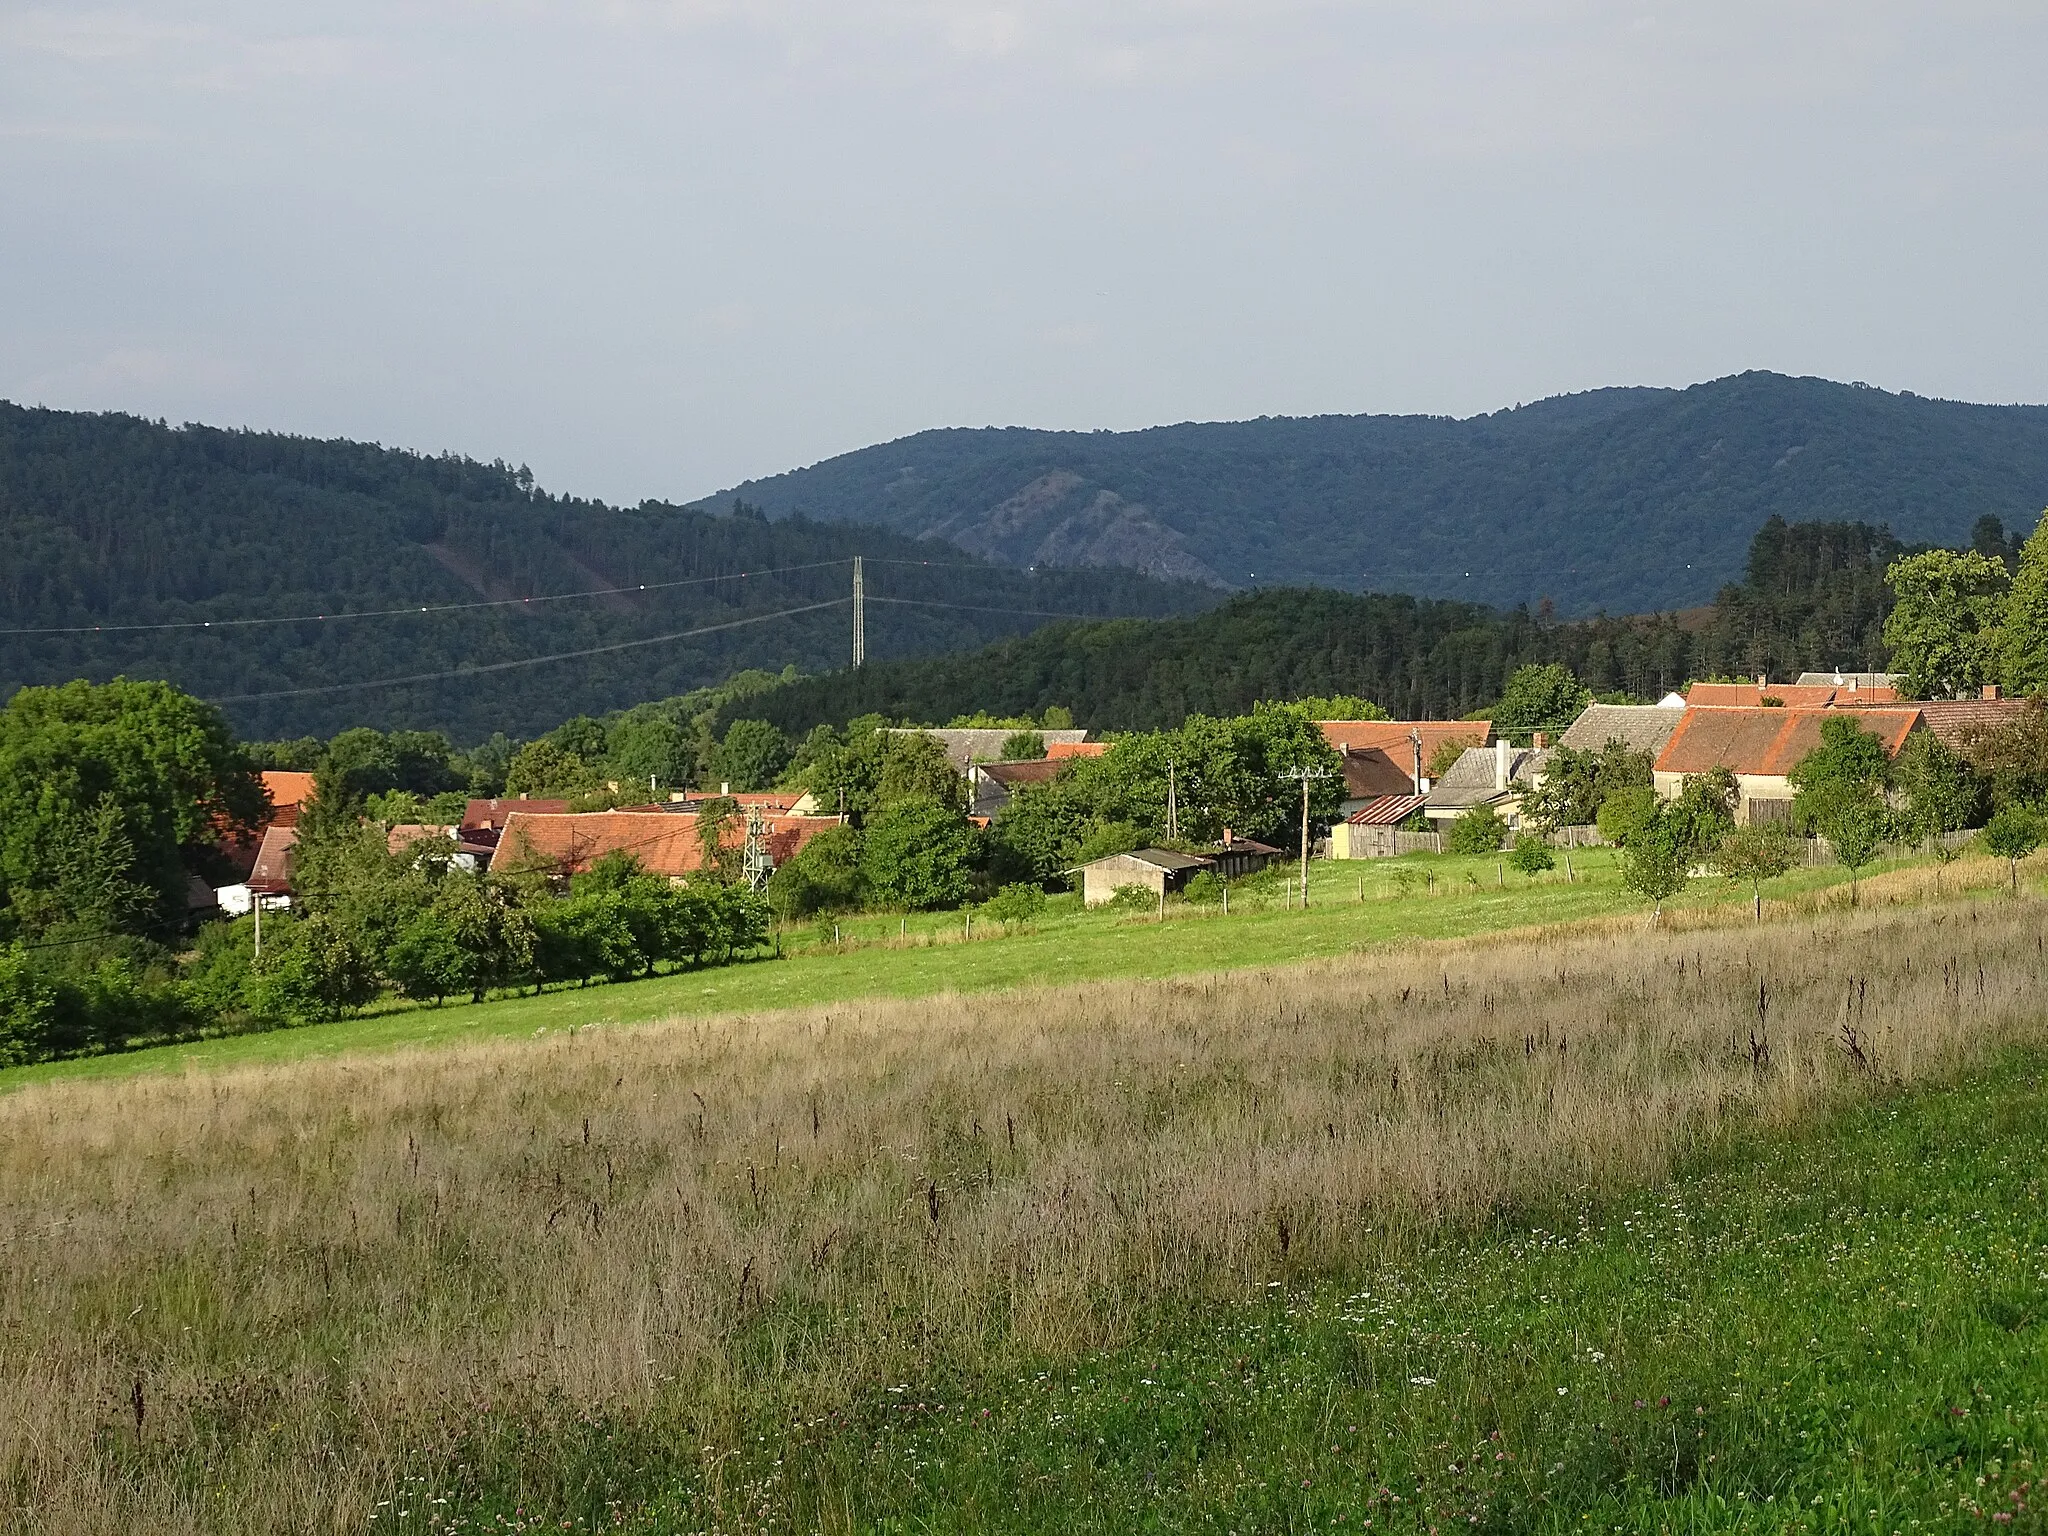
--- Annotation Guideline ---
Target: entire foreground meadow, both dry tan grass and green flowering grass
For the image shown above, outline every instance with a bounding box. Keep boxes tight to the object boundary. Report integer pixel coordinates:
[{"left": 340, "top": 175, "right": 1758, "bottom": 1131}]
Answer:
[{"left": 0, "top": 891, "right": 2048, "bottom": 1532}]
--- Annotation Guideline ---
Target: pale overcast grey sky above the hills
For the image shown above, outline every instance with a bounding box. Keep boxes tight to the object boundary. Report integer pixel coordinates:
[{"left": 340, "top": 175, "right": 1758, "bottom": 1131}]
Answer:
[{"left": 0, "top": 0, "right": 2048, "bottom": 500}]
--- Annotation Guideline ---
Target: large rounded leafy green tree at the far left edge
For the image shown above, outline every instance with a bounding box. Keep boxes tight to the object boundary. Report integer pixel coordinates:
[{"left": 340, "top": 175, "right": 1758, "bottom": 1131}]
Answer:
[{"left": 0, "top": 680, "right": 262, "bottom": 934}]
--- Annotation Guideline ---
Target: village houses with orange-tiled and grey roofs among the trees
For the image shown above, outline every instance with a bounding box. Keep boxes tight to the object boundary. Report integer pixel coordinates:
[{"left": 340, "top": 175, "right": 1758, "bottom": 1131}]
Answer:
[{"left": 211, "top": 672, "right": 2032, "bottom": 922}]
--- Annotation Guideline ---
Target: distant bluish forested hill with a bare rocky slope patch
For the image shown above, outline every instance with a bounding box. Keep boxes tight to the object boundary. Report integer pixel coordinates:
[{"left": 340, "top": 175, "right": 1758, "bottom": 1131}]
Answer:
[{"left": 696, "top": 373, "right": 2048, "bottom": 614}]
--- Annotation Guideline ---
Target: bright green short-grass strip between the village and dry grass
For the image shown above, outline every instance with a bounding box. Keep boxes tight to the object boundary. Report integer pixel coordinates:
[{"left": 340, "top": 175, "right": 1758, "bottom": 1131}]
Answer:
[{"left": 0, "top": 850, "right": 2007, "bottom": 1092}]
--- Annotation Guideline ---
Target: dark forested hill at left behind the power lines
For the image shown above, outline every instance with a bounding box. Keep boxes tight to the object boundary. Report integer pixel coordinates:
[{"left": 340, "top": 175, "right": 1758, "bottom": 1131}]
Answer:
[{"left": 0, "top": 401, "right": 1221, "bottom": 741}]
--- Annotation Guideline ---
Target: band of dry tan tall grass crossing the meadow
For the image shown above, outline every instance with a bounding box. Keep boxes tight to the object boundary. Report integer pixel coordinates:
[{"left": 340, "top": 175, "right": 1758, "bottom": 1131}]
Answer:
[{"left": 0, "top": 901, "right": 2044, "bottom": 1532}]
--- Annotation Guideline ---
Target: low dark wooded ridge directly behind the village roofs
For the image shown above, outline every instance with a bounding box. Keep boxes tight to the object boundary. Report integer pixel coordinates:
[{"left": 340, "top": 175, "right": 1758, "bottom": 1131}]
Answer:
[{"left": 719, "top": 518, "right": 1966, "bottom": 737}]
